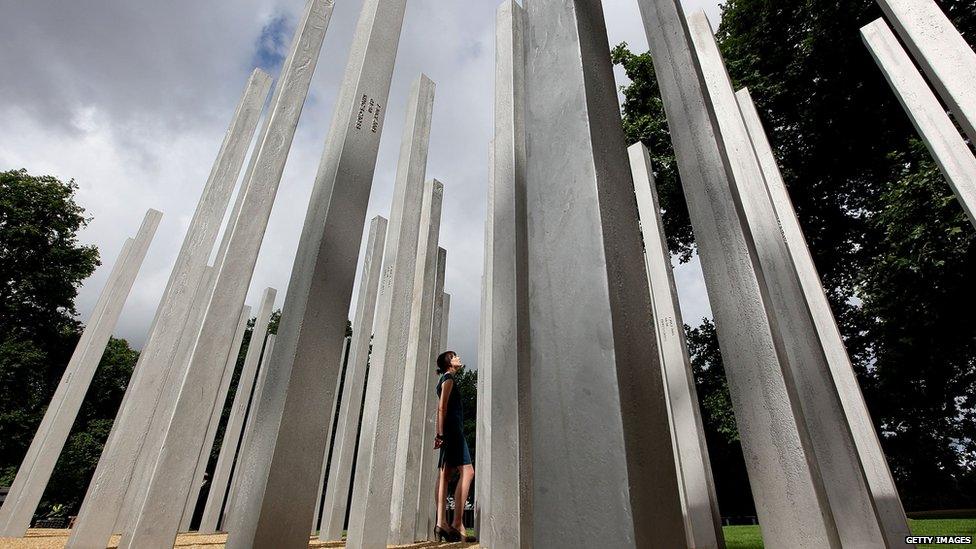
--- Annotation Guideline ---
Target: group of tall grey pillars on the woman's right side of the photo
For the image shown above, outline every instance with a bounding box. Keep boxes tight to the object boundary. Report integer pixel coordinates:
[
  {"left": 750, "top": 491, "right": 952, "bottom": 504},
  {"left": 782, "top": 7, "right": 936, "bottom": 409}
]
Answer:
[{"left": 475, "top": 0, "right": 976, "bottom": 547}]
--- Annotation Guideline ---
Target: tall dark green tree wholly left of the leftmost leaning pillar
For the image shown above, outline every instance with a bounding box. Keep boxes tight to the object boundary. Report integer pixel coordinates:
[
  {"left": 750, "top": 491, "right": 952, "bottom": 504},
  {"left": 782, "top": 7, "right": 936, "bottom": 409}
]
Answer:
[{"left": 0, "top": 170, "right": 99, "bottom": 490}]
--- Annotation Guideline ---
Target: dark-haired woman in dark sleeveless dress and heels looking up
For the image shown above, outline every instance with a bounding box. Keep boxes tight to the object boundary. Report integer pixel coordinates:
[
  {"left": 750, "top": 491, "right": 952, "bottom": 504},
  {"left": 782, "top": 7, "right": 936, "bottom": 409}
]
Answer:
[{"left": 434, "top": 351, "right": 475, "bottom": 541}]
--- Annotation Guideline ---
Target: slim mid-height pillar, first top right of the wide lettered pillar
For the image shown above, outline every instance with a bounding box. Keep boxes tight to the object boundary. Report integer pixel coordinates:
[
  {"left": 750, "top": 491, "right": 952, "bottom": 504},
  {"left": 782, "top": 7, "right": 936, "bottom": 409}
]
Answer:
[{"left": 319, "top": 216, "right": 387, "bottom": 540}]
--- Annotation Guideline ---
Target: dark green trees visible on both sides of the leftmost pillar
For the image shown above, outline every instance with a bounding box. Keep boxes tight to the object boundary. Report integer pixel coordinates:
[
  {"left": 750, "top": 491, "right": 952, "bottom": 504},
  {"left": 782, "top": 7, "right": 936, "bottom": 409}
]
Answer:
[{"left": 0, "top": 170, "right": 138, "bottom": 515}]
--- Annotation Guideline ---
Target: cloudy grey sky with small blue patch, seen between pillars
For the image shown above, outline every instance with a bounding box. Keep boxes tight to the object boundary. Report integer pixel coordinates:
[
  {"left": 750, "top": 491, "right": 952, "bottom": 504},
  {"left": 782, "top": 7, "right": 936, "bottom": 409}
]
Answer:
[{"left": 0, "top": 0, "right": 719, "bottom": 367}]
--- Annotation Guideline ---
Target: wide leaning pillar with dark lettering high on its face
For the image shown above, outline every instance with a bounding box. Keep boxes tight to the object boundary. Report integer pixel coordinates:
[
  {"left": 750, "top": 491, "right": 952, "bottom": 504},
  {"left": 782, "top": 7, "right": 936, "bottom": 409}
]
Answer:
[{"left": 227, "top": 0, "right": 405, "bottom": 548}]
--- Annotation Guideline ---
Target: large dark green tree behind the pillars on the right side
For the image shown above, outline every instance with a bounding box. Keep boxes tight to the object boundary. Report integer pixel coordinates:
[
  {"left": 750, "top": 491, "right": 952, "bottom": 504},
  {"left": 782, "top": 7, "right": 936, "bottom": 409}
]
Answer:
[{"left": 614, "top": 0, "right": 976, "bottom": 509}]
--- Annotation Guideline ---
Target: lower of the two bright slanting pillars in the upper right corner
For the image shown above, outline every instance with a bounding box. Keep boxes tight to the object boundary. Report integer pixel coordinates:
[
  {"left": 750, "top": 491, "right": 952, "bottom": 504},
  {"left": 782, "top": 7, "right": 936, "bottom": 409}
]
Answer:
[{"left": 861, "top": 19, "right": 976, "bottom": 226}]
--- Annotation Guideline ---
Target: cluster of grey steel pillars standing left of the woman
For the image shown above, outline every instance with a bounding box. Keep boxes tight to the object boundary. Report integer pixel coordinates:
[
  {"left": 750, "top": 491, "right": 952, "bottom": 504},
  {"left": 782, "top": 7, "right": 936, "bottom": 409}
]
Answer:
[{"left": 0, "top": 0, "right": 460, "bottom": 548}]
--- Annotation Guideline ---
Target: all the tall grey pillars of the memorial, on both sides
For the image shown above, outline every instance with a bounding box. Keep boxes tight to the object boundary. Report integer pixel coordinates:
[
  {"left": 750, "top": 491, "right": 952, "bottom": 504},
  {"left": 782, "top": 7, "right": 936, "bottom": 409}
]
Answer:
[{"left": 7, "top": 0, "right": 976, "bottom": 548}]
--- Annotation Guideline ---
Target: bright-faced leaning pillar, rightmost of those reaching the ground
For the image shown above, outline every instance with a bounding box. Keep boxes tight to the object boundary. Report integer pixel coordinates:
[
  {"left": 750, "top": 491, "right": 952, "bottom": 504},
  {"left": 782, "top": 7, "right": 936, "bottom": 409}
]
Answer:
[{"left": 735, "top": 89, "right": 911, "bottom": 547}]
